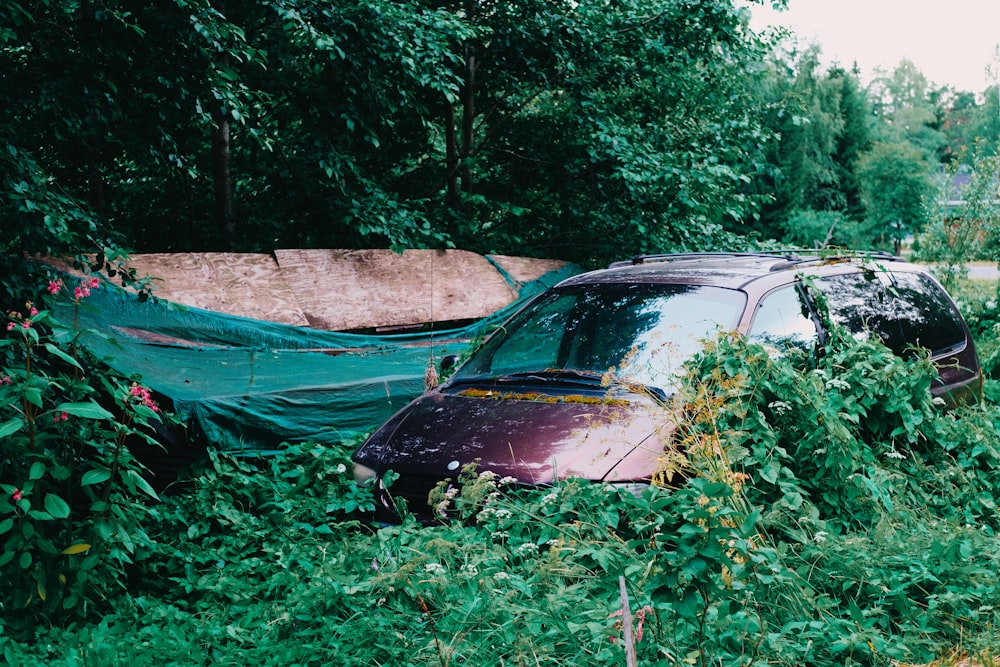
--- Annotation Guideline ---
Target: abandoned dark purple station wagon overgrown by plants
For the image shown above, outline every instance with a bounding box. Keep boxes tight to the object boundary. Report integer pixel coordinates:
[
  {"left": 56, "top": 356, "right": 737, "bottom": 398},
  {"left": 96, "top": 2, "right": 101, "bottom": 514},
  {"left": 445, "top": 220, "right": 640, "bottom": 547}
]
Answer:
[{"left": 354, "top": 251, "right": 982, "bottom": 522}]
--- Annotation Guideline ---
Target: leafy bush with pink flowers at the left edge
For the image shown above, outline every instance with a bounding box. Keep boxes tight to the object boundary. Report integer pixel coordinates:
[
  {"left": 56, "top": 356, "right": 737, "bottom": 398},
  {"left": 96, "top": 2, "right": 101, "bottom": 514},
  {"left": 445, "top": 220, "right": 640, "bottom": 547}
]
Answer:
[{"left": 0, "top": 277, "right": 173, "bottom": 634}]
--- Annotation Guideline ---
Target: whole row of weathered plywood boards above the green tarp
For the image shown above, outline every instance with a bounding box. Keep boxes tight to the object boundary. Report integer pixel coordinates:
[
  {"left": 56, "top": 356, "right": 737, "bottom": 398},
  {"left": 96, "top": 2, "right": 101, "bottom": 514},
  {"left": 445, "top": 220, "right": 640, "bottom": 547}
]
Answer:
[{"left": 46, "top": 249, "right": 566, "bottom": 331}]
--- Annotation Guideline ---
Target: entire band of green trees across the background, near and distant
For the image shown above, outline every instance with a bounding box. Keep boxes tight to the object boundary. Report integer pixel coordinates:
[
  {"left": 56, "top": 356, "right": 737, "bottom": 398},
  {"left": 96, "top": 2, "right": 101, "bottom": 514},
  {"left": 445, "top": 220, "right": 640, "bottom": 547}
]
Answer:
[{"left": 0, "top": 0, "right": 1000, "bottom": 272}]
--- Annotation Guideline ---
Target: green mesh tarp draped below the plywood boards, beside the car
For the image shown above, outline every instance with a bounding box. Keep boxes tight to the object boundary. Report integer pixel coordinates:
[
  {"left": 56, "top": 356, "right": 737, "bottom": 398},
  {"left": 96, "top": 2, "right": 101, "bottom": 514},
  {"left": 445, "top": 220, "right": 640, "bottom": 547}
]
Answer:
[{"left": 62, "top": 266, "right": 580, "bottom": 453}]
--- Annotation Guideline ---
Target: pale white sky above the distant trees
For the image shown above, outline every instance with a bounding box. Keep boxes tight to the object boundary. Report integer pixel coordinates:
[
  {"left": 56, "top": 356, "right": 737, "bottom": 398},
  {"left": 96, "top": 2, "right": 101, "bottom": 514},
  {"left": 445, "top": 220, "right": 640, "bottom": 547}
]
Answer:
[{"left": 751, "top": 0, "right": 1000, "bottom": 93}]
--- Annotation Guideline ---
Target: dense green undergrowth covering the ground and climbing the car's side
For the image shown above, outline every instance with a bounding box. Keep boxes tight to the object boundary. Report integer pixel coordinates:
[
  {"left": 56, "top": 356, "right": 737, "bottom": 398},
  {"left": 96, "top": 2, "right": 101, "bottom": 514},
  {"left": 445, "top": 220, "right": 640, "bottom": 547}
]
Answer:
[{"left": 0, "top": 280, "right": 1000, "bottom": 667}]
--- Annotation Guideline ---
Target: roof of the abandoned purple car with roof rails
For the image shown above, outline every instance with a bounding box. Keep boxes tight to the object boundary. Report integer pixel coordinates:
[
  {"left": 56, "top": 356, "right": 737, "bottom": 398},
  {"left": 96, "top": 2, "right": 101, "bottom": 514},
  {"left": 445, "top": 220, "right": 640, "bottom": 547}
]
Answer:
[{"left": 561, "top": 250, "right": 921, "bottom": 289}]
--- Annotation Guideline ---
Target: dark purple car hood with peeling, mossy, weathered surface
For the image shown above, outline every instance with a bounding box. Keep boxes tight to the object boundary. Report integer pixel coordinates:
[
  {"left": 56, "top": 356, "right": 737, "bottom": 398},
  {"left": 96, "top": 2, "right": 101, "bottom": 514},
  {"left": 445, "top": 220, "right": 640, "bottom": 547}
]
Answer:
[{"left": 354, "top": 389, "right": 673, "bottom": 484}]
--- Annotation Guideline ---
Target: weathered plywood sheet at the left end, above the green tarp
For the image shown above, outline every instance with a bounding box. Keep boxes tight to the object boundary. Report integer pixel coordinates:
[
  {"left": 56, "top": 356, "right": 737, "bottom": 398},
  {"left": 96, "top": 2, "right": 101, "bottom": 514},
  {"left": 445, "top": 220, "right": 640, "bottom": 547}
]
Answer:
[{"left": 129, "top": 252, "right": 308, "bottom": 326}]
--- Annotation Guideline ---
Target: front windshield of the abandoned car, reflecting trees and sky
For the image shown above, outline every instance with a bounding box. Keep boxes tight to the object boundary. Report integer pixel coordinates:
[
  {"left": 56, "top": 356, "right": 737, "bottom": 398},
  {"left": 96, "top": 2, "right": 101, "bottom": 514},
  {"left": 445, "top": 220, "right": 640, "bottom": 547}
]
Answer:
[{"left": 452, "top": 283, "right": 745, "bottom": 390}]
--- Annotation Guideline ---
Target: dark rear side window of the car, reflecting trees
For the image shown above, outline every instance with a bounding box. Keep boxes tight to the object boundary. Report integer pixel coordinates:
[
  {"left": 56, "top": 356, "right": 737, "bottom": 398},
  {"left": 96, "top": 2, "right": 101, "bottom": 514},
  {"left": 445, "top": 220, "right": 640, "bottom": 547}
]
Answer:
[{"left": 816, "top": 272, "right": 965, "bottom": 357}]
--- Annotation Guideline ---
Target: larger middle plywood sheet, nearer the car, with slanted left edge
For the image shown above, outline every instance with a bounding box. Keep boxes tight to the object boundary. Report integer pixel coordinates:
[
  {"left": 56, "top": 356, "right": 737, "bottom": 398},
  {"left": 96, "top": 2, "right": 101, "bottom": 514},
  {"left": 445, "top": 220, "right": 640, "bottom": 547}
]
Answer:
[{"left": 275, "top": 249, "right": 517, "bottom": 330}]
